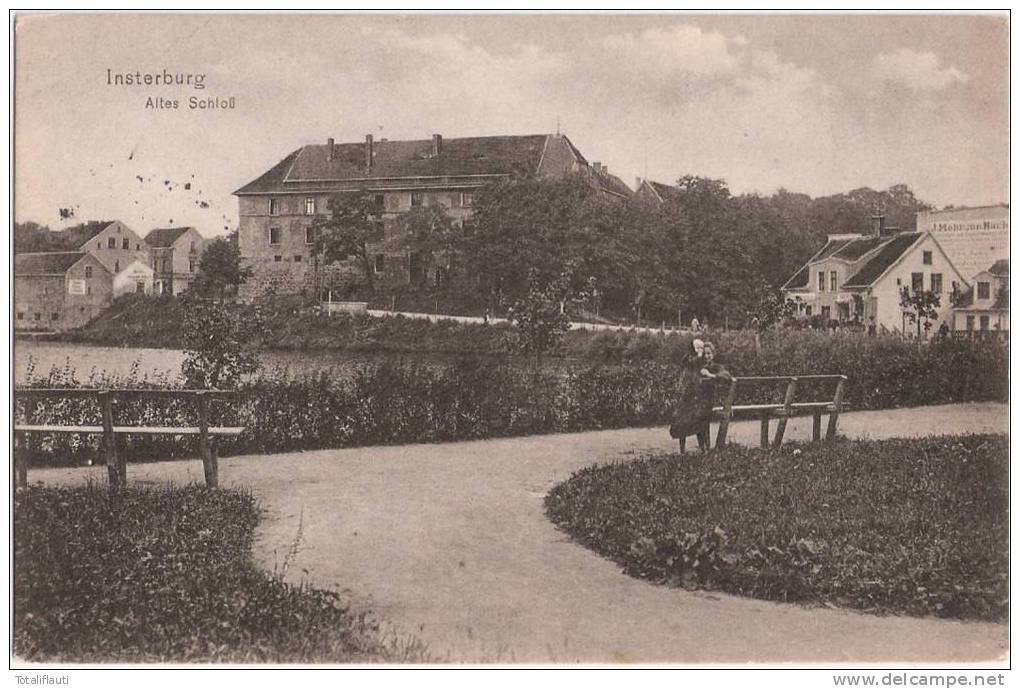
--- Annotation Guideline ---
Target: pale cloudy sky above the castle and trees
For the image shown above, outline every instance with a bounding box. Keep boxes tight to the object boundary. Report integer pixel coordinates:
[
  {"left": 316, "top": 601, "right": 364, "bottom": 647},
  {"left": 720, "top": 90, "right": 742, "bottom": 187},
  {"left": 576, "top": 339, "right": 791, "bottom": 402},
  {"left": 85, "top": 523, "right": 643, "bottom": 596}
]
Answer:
[{"left": 14, "top": 13, "right": 1009, "bottom": 236}]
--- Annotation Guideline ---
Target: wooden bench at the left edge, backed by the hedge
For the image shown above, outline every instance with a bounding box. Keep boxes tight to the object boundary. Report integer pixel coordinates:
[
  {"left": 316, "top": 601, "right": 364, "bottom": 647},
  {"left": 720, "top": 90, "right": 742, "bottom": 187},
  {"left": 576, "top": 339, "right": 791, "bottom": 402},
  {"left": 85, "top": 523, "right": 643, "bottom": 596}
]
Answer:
[{"left": 14, "top": 388, "right": 245, "bottom": 490}]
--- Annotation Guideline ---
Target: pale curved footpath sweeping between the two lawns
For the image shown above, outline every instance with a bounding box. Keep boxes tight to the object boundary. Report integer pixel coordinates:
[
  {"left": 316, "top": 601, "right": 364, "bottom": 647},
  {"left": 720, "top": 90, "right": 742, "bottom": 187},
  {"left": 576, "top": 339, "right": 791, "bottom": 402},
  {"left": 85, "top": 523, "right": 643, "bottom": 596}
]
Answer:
[{"left": 30, "top": 404, "right": 1009, "bottom": 663}]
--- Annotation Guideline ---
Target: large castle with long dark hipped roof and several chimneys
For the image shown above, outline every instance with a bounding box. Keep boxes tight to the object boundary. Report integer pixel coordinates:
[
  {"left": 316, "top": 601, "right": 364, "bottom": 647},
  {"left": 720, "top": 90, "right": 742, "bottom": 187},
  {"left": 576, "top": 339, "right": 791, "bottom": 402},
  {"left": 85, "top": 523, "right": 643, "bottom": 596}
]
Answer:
[{"left": 234, "top": 134, "right": 630, "bottom": 294}]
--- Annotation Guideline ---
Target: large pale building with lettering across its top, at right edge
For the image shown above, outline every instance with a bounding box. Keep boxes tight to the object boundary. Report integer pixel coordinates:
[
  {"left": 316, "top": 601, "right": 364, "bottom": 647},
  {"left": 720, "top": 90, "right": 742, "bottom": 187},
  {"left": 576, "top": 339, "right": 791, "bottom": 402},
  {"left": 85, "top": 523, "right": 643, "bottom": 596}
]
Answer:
[{"left": 917, "top": 204, "right": 1010, "bottom": 281}]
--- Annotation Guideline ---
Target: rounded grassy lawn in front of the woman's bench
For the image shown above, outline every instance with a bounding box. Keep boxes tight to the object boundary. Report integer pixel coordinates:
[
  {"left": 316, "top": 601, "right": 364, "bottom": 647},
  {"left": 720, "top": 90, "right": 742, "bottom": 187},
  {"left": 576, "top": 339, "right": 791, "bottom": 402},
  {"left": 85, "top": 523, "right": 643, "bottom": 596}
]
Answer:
[{"left": 546, "top": 435, "right": 1009, "bottom": 623}]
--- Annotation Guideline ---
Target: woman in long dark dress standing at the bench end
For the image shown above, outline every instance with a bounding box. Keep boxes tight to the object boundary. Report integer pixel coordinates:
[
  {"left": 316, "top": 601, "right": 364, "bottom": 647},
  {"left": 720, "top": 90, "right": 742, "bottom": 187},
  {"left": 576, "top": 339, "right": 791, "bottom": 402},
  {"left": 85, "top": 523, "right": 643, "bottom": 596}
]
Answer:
[{"left": 669, "top": 340, "right": 732, "bottom": 454}]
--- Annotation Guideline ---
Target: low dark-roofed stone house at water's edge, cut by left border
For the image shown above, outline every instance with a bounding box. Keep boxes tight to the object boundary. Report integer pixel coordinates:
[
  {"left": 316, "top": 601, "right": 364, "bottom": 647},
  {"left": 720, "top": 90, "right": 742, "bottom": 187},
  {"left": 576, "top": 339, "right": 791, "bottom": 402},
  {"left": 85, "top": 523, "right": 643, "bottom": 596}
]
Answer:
[{"left": 14, "top": 251, "right": 113, "bottom": 331}]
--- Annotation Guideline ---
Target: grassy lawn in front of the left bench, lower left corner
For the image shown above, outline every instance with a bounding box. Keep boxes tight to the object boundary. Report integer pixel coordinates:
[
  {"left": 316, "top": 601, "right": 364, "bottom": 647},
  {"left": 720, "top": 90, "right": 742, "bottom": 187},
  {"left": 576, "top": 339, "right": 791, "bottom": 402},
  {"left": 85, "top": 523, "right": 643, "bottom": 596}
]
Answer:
[{"left": 13, "top": 486, "right": 427, "bottom": 663}]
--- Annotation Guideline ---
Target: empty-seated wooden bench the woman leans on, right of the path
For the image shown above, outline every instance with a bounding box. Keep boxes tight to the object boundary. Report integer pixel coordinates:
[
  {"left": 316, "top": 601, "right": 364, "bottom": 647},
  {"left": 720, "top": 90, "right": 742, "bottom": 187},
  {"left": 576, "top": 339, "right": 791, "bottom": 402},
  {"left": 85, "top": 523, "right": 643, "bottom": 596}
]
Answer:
[{"left": 712, "top": 376, "right": 847, "bottom": 447}]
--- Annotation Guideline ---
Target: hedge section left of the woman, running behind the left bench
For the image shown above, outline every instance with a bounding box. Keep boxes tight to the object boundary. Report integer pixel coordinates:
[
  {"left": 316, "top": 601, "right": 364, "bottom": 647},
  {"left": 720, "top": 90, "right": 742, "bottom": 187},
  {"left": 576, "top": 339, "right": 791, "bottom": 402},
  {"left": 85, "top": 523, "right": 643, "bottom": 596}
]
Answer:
[{"left": 15, "top": 360, "right": 679, "bottom": 461}]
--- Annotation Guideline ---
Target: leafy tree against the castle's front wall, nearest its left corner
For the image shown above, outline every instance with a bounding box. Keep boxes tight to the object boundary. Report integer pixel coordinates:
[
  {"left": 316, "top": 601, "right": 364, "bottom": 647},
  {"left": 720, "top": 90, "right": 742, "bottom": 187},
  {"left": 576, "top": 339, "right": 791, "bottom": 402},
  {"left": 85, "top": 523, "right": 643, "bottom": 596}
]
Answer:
[{"left": 312, "top": 190, "right": 383, "bottom": 290}]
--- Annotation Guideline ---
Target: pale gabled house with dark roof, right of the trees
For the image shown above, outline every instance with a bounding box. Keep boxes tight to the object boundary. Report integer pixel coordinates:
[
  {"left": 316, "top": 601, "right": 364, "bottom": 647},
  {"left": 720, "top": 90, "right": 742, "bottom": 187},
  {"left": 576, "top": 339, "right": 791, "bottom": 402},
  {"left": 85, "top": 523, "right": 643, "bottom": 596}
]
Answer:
[{"left": 782, "top": 216, "right": 966, "bottom": 335}]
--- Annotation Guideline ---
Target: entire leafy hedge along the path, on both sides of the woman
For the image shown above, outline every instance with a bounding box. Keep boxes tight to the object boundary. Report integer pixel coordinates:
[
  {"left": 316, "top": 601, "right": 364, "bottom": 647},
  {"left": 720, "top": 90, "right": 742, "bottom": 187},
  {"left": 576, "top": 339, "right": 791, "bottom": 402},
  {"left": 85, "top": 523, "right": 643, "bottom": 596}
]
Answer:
[{"left": 16, "top": 340, "right": 1009, "bottom": 460}]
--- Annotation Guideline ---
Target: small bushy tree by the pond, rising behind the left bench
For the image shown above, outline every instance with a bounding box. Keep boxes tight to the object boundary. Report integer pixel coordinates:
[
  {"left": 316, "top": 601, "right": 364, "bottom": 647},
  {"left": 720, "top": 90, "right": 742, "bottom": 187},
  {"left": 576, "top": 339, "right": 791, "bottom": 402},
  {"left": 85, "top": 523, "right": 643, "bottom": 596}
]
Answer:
[{"left": 182, "top": 300, "right": 264, "bottom": 389}]
